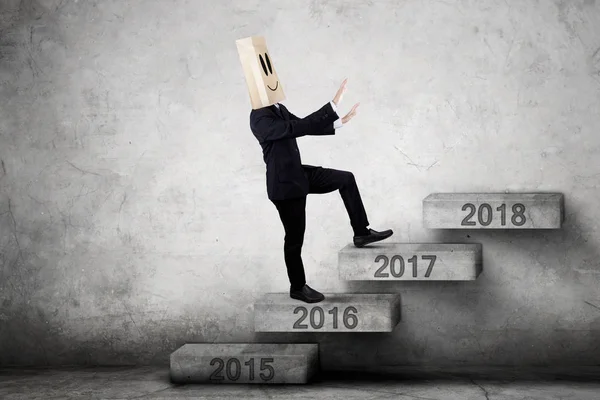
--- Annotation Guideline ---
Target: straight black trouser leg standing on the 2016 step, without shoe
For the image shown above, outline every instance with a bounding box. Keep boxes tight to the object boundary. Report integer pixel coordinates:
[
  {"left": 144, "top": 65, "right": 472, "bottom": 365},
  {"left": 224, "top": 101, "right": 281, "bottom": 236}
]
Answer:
[{"left": 273, "top": 197, "right": 306, "bottom": 289}]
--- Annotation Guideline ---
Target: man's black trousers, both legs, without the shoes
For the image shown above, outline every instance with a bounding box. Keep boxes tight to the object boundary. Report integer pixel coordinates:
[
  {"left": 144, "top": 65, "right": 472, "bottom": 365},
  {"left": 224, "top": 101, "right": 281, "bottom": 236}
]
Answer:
[{"left": 272, "top": 167, "right": 369, "bottom": 289}]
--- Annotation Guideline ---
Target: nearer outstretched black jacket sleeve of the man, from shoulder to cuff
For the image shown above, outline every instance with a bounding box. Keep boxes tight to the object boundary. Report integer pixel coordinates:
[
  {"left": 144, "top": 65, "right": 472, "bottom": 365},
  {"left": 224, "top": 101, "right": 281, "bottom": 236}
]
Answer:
[{"left": 250, "top": 103, "right": 338, "bottom": 142}]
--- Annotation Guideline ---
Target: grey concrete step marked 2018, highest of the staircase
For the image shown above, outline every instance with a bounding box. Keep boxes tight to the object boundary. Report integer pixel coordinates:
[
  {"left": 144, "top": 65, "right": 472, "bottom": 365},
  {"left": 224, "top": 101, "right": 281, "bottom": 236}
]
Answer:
[{"left": 423, "top": 193, "right": 564, "bottom": 229}]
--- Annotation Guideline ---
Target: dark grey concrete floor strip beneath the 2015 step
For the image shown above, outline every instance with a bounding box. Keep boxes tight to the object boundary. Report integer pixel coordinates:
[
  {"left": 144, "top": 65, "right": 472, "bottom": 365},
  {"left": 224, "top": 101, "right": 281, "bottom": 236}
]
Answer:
[{"left": 0, "top": 367, "right": 600, "bottom": 400}]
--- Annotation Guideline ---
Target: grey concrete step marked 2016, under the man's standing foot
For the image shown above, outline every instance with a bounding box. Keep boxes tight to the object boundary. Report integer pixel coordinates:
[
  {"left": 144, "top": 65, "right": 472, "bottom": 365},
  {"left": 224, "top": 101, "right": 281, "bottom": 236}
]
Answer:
[{"left": 254, "top": 293, "right": 400, "bottom": 332}]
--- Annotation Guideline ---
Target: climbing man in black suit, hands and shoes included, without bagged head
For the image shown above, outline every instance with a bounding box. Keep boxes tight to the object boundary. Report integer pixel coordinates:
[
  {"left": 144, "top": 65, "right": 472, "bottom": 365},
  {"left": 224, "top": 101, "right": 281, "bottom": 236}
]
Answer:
[{"left": 250, "top": 80, "right": 393, "bottom": 303}]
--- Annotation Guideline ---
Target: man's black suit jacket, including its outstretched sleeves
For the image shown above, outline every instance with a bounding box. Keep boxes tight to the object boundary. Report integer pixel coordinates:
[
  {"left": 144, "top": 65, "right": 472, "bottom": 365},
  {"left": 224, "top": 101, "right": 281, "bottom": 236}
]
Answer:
[{"left": 250, "top": 103, "right": 338, "bottom": 200}]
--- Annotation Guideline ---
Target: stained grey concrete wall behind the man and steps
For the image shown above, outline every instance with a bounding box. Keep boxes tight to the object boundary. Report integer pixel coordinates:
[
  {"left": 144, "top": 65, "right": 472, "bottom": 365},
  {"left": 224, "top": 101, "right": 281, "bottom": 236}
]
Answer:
[{"left": 0, "top": 0, "right": 600, "bottom": 368}]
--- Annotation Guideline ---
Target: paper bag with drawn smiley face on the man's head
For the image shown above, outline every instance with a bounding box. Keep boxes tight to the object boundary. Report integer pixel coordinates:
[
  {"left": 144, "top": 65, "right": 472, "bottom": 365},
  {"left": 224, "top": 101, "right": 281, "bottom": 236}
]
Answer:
[{"left": 235, "top": 36, "right": 285, "bottom": 110}]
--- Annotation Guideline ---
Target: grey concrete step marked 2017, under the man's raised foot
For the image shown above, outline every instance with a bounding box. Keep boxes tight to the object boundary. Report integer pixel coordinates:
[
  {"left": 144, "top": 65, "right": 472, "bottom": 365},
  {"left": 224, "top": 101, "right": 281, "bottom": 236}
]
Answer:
[{"left": 338, "top": 243, "right": 482, "bottom": 281}]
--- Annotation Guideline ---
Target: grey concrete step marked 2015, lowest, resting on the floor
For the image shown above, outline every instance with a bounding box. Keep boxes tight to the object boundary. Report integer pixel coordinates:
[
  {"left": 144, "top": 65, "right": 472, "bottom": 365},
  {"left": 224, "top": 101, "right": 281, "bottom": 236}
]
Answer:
[{"left": 170, "top": 343, "right": 319, "bottom": 384}]
